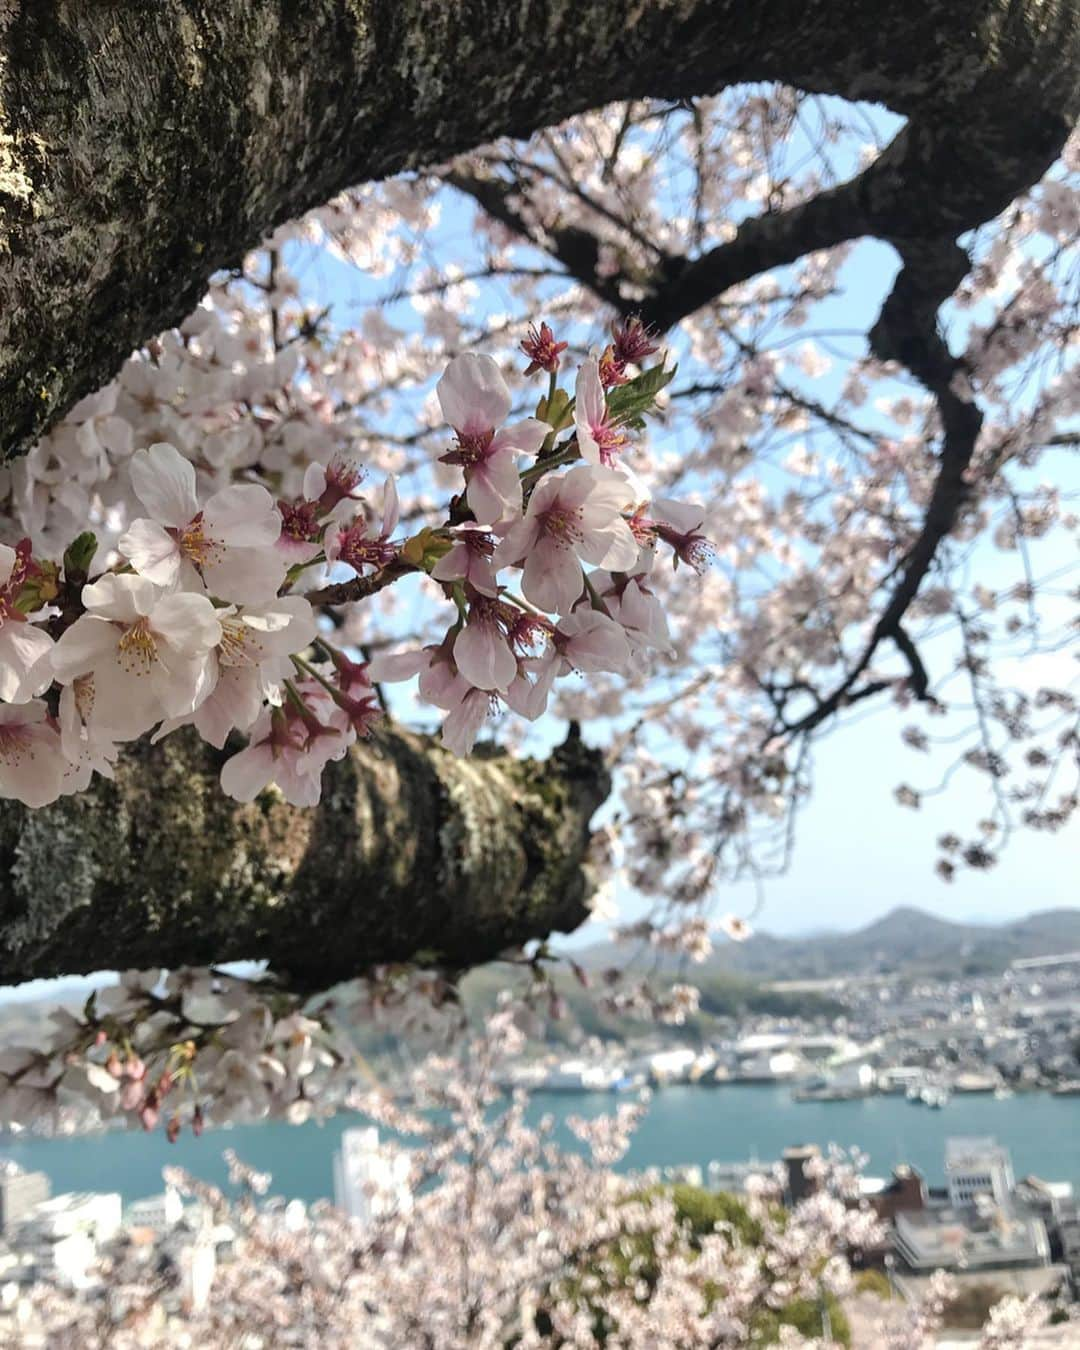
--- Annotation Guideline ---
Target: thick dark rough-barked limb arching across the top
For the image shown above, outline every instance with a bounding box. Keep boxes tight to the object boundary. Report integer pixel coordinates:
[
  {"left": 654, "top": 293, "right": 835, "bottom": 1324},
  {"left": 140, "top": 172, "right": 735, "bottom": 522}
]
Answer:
[{"left": 0, "top": 0, "right": 1080, "bottom": 459}]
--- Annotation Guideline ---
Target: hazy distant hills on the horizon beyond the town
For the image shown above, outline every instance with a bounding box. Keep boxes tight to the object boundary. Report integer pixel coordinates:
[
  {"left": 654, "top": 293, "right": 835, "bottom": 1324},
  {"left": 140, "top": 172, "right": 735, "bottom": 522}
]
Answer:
[{"left": 578, "top": 906, "right": 1080, "bottom": 980}]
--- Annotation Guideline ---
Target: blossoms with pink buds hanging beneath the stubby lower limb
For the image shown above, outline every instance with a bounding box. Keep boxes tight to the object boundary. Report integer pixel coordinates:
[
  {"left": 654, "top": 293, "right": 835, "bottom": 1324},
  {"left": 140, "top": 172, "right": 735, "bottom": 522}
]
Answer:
[{"left": 0, "top": 968, "right": 462, "bottom": 1142}]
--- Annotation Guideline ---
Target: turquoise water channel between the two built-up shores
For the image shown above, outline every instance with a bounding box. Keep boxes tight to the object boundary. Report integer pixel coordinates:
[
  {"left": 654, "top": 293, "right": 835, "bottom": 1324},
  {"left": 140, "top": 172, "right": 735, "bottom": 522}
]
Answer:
[{"left": 0, "top": 1084, "right": 1080, "bottom": 1202}]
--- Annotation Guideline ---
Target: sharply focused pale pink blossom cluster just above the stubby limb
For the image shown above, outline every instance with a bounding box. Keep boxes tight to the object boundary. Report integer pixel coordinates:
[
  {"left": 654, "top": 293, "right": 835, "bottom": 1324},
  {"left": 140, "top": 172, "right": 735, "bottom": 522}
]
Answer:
[{"left": 0, "top": 324, "right": 709, "bottom": 807}]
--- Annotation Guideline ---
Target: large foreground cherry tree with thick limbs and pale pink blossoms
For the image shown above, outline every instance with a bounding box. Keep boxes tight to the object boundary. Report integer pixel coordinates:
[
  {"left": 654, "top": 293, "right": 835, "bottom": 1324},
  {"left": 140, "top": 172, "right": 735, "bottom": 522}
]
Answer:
[{"left": 0, "top": 10, "right": 1080, "bottom": 1345}]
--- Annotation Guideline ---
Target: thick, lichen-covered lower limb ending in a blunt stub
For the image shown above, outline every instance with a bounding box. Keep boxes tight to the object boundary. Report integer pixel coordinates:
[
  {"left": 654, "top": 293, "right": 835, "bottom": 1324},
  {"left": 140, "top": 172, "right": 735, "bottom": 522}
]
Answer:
[{"left": 0, "top": 728, "right": 609, "bottom": 990}]
